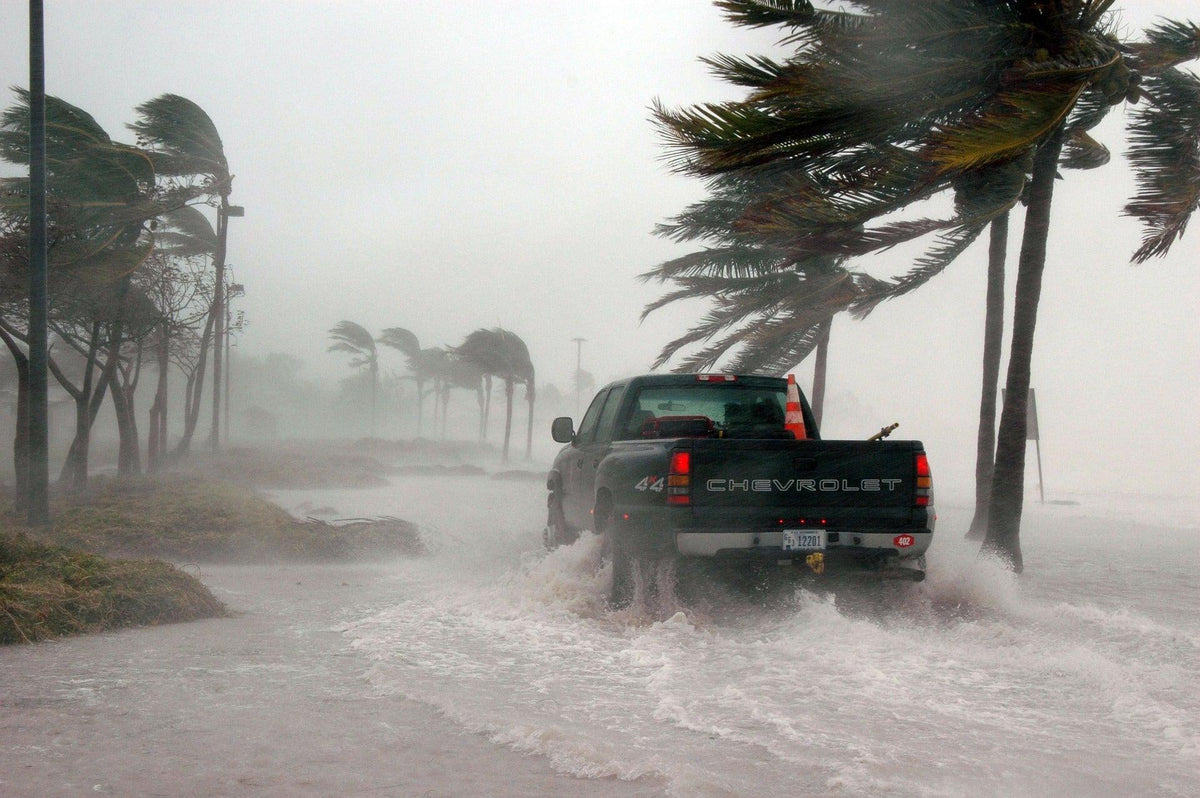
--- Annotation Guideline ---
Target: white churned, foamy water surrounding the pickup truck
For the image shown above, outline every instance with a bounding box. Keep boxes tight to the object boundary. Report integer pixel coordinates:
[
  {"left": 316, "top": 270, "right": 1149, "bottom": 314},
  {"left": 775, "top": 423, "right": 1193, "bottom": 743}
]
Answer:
[{"left": 265, "top": 479, "right": 1200, "bottom": 796}]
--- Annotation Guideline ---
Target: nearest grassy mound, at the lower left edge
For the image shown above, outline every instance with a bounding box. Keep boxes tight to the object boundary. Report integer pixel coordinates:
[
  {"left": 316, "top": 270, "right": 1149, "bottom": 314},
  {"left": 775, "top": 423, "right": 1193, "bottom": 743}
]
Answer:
[{"left": 0, "top": 534, "right": 227, "bottom": 644}]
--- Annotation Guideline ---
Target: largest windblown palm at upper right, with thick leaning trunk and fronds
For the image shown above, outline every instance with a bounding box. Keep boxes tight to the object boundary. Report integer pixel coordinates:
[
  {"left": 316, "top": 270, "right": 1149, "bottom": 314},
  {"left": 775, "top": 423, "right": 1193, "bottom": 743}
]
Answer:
[{"left": 656, "top": 0, "right": 1200, "bottom": 569}]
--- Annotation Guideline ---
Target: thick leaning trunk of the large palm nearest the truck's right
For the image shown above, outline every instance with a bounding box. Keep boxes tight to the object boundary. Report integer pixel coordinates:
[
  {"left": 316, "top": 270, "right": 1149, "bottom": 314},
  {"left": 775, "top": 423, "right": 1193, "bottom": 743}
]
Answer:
[{"left": 983, "top": 128, "right": 1063, "bottom": 572}]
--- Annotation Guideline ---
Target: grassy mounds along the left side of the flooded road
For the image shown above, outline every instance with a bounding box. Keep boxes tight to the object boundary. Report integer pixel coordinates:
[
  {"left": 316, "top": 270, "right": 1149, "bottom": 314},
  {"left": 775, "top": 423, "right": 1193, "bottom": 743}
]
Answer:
[{"left": 0, "top": 448, "right": 436, "bottom": 644}]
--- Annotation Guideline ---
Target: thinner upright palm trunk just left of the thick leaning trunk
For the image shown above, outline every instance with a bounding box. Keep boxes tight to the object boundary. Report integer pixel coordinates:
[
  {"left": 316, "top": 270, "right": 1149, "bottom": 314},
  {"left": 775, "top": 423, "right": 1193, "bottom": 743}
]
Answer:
[{"left": 967, "top": 212, "right": 1008, "bottom": 540}]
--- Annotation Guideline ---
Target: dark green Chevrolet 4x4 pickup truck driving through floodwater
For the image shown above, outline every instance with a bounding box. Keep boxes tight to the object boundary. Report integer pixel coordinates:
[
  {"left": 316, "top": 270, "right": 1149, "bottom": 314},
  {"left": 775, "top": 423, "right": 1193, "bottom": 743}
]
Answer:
[{"left": 545, "top": 374, "right": 935, "bottom": 605}]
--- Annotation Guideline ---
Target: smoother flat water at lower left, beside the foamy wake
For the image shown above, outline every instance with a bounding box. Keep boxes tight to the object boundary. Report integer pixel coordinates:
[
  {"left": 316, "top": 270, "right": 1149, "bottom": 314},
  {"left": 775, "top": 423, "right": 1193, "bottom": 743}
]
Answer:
[{"left": 0, "top": 556, "right": 662, "bottom": 798}]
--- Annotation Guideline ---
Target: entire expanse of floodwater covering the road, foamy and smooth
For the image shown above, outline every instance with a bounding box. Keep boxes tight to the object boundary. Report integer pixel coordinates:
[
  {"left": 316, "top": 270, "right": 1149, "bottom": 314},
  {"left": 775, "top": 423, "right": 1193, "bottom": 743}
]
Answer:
[{"left": 0, "top": 476, "right": 1200, "bottom": 796}]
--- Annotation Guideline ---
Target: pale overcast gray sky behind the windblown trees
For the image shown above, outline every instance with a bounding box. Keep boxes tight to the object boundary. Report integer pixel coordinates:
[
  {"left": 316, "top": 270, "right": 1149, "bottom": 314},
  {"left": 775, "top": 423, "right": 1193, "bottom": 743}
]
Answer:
[{"left": 0, "top": 0, "right": 1200, "bottom": 496}]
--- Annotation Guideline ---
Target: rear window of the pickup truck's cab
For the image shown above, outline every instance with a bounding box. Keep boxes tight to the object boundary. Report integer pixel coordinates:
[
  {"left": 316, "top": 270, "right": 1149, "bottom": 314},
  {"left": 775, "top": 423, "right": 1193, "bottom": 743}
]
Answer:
[{"left": 618, "top": 383, "right": 792, "bottom": 439}]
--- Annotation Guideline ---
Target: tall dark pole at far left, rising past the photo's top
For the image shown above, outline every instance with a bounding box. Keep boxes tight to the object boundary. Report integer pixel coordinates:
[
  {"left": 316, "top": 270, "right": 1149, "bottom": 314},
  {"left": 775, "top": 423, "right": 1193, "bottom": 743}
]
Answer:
[{"left": 26, "top": 0, "right": 50, "bottom": 526}]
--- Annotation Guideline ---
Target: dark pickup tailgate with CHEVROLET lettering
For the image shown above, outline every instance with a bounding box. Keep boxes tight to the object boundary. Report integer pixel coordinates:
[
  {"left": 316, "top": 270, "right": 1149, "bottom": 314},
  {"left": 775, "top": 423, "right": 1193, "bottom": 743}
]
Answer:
[{"left": 691, "top": 438, "right": 925, "bottom": 528}]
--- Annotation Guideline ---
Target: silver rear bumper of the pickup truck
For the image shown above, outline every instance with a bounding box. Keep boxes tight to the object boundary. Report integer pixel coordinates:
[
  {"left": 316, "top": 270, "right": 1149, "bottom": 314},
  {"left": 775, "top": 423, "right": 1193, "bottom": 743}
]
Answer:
[{"left": 674, "top": 529, "right": 934, "bottom": 559}]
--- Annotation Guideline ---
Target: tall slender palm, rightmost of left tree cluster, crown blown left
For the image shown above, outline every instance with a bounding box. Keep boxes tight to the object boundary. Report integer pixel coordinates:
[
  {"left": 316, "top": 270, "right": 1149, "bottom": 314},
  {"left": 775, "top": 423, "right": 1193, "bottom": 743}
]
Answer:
[{"left": 128, "top": 94, "right": 233, "bottom": 451}]
